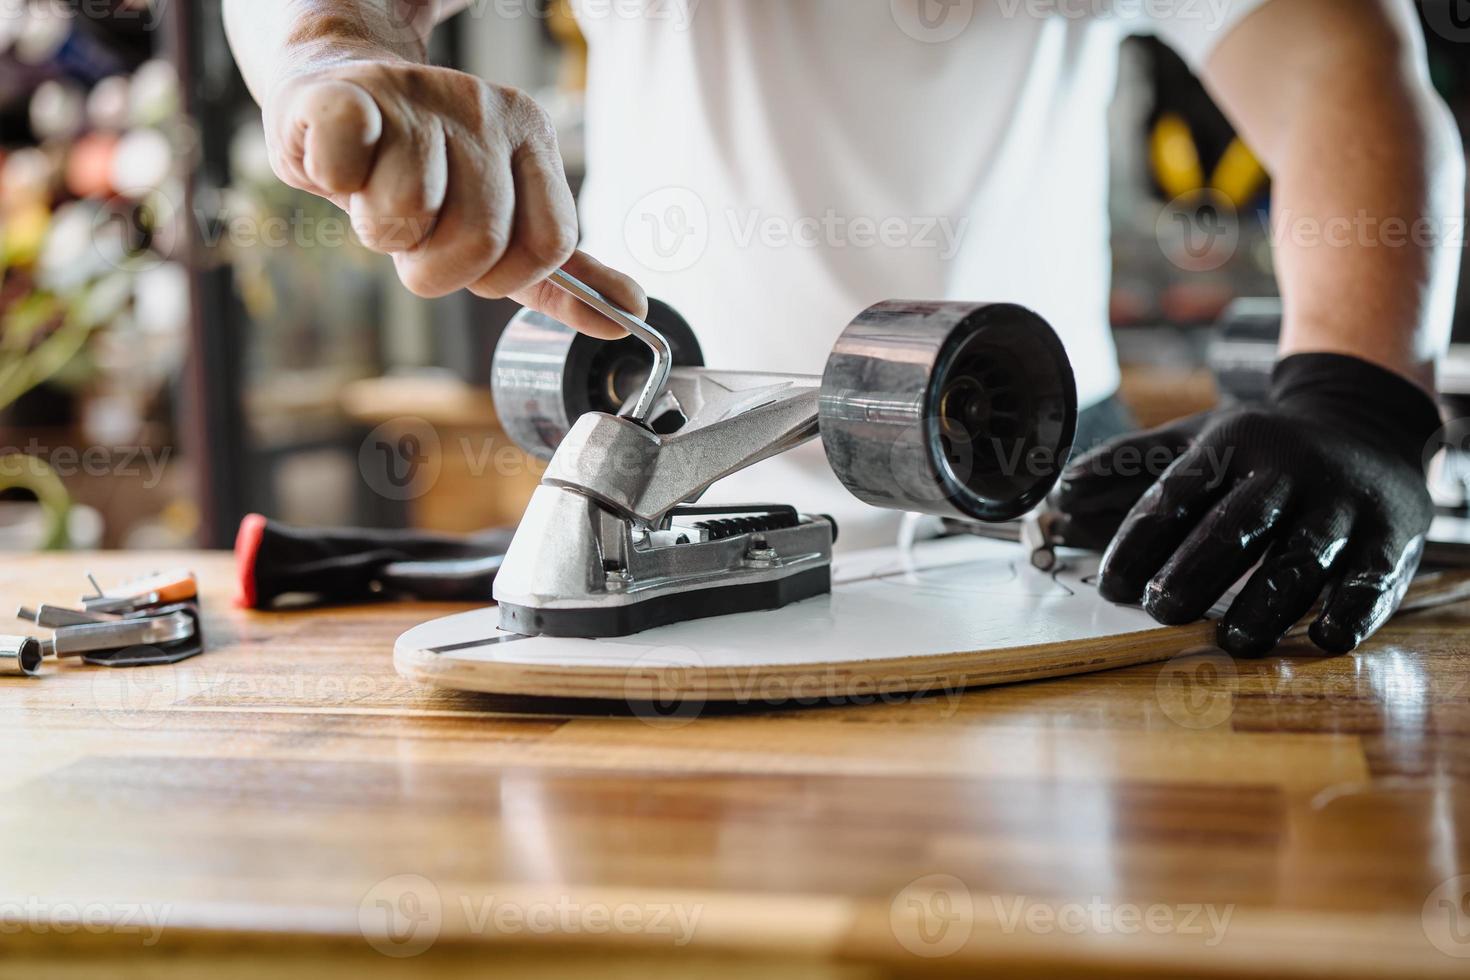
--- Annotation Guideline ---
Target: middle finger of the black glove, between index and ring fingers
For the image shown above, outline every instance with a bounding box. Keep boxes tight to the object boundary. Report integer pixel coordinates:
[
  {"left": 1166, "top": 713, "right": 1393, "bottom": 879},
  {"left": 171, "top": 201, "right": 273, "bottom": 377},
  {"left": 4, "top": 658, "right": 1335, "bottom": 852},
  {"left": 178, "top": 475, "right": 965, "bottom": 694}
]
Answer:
[{"left": 1144, "top": 473, "right": 1291, "bottom": 626}]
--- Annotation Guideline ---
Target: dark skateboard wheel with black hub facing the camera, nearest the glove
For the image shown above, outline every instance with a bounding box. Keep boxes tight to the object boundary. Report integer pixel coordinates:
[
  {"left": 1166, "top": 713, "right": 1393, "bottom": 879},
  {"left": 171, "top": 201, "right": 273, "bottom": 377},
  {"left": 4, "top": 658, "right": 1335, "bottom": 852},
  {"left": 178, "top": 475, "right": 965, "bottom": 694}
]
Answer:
[{"left": 817, "top": 300, "right": 1078, "bottom": 522}]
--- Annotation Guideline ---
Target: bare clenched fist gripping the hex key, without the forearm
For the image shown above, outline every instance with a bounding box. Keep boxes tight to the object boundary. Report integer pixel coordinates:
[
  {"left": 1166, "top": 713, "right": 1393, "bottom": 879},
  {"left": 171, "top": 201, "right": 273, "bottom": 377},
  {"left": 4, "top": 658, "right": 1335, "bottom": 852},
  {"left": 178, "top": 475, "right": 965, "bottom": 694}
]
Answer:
[{"left": 265, "top": 57, "right": 647, "bottom": 338}]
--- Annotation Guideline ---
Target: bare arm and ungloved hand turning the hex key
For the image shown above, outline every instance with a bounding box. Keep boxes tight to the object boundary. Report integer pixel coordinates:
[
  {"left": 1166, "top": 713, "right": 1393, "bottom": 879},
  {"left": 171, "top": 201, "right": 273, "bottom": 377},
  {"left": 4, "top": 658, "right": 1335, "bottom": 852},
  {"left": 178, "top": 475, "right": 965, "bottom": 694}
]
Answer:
[{"left": 225, "top": 0, "right": 647, "bottom": 336}]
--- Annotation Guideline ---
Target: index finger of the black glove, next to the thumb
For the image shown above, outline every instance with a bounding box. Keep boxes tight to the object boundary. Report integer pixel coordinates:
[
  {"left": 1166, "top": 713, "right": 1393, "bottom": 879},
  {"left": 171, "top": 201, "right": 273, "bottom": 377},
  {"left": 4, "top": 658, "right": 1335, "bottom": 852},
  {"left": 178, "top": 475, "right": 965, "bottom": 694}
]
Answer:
[{"left": 1098, "top": 445, "right": 1229, "bottom": 602}]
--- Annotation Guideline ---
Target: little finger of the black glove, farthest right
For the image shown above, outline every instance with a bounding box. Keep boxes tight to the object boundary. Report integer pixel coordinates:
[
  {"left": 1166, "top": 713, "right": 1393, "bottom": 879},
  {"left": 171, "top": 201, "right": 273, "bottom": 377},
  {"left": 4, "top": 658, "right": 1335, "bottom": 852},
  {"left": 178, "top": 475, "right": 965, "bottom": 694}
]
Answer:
[{"left": 1308, "top": 529, "right": 1424, "bottom": 654}]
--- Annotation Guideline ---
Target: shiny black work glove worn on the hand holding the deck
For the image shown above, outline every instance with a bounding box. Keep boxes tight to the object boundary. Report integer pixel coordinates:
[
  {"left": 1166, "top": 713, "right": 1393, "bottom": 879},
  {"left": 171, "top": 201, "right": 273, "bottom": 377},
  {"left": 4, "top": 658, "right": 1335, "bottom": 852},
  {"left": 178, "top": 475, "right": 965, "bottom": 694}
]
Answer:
[{"left": 1054, "top": 354, "right": 1441, "bottom": 655}]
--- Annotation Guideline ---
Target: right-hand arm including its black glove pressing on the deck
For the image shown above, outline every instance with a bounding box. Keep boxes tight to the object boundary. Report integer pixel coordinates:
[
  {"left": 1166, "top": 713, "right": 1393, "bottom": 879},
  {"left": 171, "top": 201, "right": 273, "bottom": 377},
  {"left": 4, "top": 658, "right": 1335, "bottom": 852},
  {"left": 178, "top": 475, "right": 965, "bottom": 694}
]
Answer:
[{"left": 1055, "top": 0, "right": 1464, "bottom": 655}]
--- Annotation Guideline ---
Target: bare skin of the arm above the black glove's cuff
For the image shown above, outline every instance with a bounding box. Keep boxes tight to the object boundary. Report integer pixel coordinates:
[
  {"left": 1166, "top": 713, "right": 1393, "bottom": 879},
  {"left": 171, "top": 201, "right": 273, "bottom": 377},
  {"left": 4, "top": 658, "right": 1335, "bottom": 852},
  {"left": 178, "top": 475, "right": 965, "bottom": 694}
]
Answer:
[{"left": 1204, "top": 0, "right": 1464, "bottom": 389}]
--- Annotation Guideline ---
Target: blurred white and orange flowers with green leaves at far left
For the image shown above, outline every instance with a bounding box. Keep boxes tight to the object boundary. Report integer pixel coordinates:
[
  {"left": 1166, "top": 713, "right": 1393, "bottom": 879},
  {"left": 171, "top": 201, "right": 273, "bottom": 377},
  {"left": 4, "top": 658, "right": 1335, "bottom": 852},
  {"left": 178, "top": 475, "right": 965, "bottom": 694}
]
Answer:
[{"left": 0, "top": 38, "right": 194, "bottom": 548}]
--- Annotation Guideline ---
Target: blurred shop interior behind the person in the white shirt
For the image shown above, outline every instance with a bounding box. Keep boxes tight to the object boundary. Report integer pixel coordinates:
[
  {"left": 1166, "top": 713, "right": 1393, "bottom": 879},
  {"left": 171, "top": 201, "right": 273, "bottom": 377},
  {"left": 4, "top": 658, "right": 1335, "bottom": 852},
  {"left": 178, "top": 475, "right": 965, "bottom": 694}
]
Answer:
[{"left": 0, "top": 0, "right": 1470, "bottom": 551}]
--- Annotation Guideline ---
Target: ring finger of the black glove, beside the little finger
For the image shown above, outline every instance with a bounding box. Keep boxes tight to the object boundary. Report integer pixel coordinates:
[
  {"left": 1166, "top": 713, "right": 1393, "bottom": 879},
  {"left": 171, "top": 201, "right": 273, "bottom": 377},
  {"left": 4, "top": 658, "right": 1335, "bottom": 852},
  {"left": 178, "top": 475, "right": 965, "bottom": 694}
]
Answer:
[{"left": 1216, "top": 500, "right": 1352, "bottom": 657}]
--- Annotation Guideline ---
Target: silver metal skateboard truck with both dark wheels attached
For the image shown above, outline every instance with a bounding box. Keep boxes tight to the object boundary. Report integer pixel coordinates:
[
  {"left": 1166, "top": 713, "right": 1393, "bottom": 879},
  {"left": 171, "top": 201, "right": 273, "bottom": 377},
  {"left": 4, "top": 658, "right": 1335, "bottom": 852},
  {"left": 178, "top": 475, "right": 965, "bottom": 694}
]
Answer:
[{"left": 491, "top": 273, "right": 1078, "bottom": 638}]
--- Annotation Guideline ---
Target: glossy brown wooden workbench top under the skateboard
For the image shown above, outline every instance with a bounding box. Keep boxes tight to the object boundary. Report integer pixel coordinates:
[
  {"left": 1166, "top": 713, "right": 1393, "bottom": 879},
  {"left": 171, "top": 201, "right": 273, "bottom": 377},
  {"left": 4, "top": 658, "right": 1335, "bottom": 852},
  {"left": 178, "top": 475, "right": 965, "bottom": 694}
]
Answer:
[{"left": 0, "top": 555, "right": 1470, "bottom": 979}]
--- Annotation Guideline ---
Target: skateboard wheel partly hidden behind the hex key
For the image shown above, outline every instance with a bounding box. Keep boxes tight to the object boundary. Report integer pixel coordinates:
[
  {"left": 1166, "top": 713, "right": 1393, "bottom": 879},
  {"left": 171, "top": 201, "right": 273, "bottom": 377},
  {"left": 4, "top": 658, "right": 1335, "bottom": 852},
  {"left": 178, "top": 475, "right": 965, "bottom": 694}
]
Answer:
[{"left": 490, "top": 300, "right": 704, "bottom": 460}]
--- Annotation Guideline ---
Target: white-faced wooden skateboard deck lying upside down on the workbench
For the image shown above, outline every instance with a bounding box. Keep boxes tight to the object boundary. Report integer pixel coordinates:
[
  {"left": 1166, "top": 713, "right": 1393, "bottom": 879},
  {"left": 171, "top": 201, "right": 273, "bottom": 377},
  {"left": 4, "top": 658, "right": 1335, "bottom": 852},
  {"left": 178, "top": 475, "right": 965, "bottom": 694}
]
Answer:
[{"left": 394, "top": 538, "right": 1467, "bottom": 702}]
